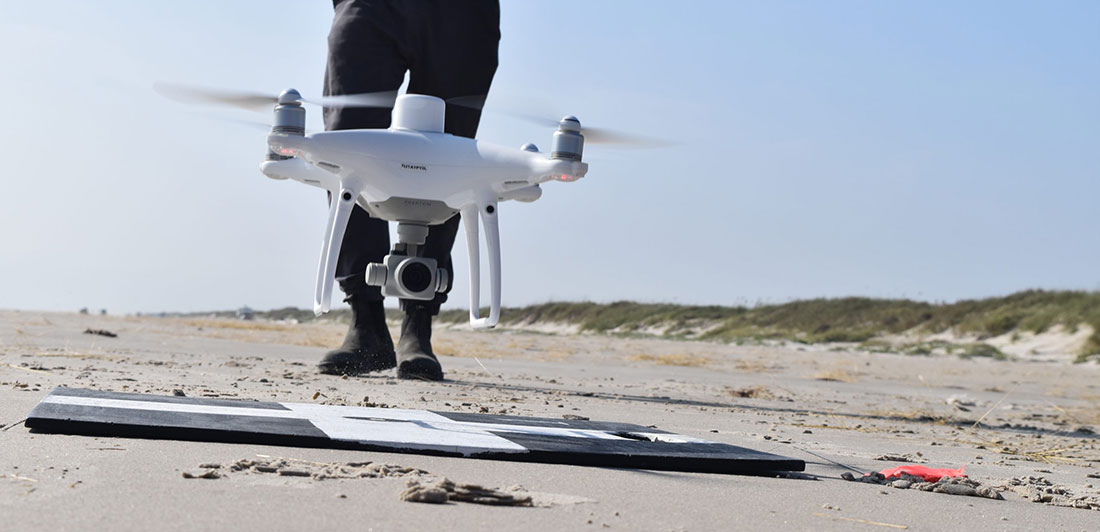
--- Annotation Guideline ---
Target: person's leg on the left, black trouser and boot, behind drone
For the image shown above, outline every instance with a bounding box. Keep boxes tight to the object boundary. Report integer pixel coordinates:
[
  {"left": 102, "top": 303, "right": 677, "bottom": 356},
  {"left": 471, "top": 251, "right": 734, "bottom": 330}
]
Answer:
[{"left": 318, "top": 0, "right": 408, "bottom": 375}]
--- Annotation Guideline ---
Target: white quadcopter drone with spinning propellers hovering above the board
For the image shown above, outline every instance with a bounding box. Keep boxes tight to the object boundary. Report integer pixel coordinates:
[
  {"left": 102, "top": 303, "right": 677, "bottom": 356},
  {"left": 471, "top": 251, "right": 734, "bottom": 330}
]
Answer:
[{"left": 161, "top": 88, "right": 642, "bottom": 329}]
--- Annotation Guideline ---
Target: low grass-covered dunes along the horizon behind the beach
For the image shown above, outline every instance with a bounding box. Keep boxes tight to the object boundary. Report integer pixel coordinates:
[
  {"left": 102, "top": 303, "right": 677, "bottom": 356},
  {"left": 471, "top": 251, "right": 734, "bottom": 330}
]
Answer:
[{"left": 176, "top": 290, "right": 1100, "bottom": 362}]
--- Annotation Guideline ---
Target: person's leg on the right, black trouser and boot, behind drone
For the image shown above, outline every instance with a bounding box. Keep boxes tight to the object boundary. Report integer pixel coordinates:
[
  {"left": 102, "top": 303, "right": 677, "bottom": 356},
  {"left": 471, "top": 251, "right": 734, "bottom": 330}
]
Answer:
[{"left": 397, "top": 0, "right": 501, "bottom": 380}]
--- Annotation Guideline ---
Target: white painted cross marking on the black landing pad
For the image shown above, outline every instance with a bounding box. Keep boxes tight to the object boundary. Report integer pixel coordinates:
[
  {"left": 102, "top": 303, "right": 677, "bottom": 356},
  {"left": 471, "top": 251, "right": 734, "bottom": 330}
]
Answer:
[{"left": 42, "top": 395, "right": 714, "bottom": 455}]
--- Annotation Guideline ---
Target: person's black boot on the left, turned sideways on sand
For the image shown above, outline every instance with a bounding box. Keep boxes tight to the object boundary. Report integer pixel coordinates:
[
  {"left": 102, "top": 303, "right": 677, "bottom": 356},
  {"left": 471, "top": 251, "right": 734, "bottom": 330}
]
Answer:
[{"left": 317, "top": 282, "right": 397, "bottom": 375}]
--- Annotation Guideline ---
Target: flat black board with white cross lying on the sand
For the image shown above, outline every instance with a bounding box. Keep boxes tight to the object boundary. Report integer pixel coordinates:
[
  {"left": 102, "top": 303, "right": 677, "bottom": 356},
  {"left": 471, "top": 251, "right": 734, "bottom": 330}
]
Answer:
[{"left": 26, "top": 388, "right": 805, "bottom": 474}]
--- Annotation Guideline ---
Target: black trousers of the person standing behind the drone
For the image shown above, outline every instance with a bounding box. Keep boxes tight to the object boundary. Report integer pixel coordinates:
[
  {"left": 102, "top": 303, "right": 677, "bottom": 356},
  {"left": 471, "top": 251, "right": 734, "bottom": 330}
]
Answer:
[{"left": 325, "top": 0, "right": 501, "bottom": 313}]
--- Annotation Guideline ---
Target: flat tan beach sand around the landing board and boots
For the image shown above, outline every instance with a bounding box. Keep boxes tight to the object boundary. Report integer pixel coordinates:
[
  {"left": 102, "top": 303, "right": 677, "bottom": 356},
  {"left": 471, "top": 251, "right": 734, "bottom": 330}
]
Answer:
[{"left": 0, "top": 311, "right": 1100, "bottom": 531}]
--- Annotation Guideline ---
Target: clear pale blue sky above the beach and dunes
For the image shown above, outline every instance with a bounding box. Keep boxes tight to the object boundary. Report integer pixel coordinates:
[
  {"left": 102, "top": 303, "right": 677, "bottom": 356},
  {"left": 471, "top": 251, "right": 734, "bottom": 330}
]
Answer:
[{"left": 0, "top": 0, "right": 1100, "bottom": 312}]
